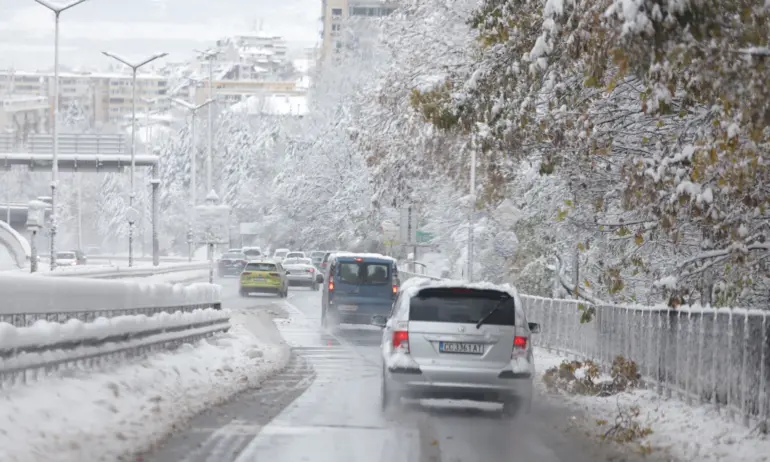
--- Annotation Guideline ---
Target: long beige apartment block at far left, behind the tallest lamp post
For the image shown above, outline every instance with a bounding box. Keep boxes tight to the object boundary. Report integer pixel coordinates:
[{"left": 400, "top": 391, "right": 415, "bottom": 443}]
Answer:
[{"left": 0, "top": 70, "right": 168, "bottom": 128}]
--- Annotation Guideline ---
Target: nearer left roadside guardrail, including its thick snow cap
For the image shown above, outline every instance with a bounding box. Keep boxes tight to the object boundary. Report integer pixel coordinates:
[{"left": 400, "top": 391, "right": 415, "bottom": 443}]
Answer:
[{"left": 0, "top": 309, "right": 230, "bottom": 388}]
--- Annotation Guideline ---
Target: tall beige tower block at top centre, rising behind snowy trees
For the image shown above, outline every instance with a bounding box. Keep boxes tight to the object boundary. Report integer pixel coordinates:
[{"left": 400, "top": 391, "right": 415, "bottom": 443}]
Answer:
[{"left": 321, "top": 0, "right": 397, "bottom": 62}]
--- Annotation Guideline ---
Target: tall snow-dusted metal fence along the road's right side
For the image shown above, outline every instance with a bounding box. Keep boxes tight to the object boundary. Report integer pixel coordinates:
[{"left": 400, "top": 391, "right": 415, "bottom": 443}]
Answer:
[{"left": 400, "top": 272, "right": 770, "bottom": 425}]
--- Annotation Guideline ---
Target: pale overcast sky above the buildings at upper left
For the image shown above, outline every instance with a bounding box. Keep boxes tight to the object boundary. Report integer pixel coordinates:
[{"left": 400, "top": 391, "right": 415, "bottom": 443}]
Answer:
[{"left": 0, "top": 0, "right": 321, "bottom": 70}]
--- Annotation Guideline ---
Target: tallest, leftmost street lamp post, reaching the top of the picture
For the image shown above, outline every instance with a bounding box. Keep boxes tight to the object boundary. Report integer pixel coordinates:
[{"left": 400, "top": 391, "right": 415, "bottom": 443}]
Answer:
[{"left": 35, "top": 0, "right": 91, "bottom": 270}]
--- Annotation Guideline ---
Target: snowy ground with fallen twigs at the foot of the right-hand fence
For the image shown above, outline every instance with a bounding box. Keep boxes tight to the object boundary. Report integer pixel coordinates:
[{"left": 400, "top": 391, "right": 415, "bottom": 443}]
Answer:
[{"left": 535, "top": 348, "right": 770, "bottom": 462}]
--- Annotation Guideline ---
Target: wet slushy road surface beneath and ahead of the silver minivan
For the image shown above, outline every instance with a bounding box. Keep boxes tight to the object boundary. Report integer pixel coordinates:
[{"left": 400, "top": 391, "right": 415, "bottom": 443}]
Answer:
[{"left": 146, "top": 280, "right": 660, "bottom": 462}]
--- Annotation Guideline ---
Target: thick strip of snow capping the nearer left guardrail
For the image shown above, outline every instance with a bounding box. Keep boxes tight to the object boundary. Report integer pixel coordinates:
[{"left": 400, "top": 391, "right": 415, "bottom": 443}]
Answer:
[{"left": 0, "top": 309, "right": 230, "bottom": 351}]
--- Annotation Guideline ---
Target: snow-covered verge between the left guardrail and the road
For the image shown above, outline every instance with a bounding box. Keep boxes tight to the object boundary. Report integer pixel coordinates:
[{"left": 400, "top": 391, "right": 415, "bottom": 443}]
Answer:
[{"left": 0, "top": 313, "right": 289, "bottom": 462}]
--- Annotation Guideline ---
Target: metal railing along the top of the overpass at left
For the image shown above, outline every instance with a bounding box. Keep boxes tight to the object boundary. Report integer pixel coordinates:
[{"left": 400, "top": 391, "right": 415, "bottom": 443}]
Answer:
[{"left": 0, "top": 133, "right": 129, "bottom": 155}]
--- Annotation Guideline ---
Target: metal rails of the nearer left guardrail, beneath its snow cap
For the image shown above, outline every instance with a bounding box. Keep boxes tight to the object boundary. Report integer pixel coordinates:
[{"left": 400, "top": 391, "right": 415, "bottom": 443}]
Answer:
[{"left": 0, "top": 312, "right": 230, "bottom": 389}]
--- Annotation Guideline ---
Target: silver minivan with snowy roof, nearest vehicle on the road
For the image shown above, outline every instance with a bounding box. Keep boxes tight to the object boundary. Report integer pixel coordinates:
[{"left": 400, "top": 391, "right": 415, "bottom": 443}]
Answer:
[{"left": 372, "top": 278, "right": 540, "bottom": 416}]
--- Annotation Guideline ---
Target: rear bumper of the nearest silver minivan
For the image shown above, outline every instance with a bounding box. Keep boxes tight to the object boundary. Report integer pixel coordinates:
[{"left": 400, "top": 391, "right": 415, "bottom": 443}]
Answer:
[{"left": 385, "top": 367, "right": 533, "bottom": 401}]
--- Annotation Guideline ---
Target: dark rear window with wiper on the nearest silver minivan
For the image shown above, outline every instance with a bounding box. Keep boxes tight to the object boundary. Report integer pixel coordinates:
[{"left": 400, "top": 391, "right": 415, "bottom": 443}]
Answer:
[{"left": 409, "top": 288, "right": 516, "bottom": 326}]
